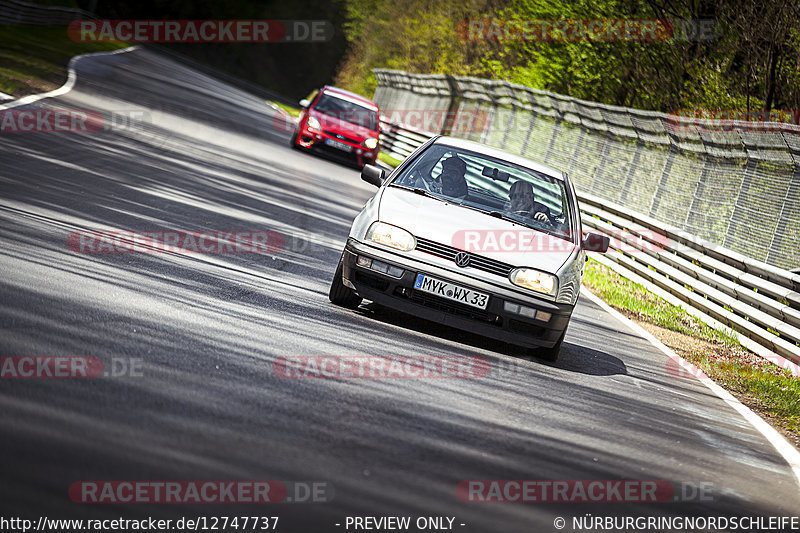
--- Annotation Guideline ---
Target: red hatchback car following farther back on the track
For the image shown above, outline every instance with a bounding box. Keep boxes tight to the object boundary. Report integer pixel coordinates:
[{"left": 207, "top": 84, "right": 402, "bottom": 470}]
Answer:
[{"left": 291, "top": 85, "right": 381, "bottom": 168}]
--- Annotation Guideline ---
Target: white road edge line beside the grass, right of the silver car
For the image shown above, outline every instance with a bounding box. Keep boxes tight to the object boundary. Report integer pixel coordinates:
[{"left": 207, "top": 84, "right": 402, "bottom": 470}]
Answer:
[{"left": 581, "top": 285, "right": 800, "bottom": 486}]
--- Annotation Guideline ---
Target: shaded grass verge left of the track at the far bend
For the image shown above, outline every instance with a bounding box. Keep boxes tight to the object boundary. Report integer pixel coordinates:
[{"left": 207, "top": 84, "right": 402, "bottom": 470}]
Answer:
[{"left": 0, "top": 25, "right": 128, "bottom": 98}]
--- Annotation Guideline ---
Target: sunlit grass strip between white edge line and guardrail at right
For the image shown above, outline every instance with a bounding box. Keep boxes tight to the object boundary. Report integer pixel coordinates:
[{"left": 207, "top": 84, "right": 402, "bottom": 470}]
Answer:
[{"left": 583, "top": 259, "right": 800, "bottom": 447}]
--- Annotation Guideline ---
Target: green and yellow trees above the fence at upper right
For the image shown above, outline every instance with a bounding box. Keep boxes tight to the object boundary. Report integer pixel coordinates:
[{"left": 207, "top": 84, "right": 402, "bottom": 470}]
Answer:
[{"left": 337, "top": 0, "right": 800, "bottom": 115}]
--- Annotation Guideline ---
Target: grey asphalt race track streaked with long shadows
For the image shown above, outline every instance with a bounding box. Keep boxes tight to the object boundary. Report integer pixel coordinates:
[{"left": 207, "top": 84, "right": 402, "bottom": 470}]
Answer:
[{"left": 0, "top": 46, "right": 800, "bottom": 533}]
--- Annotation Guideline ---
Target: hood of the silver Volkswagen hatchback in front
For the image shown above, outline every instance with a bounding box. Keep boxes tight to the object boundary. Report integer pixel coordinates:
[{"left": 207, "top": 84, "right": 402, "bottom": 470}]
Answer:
[{"left": 378, "top": 187, "right": 577, "bottom": 273}]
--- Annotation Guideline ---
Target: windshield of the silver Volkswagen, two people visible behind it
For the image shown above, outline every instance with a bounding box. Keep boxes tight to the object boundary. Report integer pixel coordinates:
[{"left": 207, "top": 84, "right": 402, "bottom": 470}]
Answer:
[{"left": 391, "top": 144, "right": 575, "bottom": 242}]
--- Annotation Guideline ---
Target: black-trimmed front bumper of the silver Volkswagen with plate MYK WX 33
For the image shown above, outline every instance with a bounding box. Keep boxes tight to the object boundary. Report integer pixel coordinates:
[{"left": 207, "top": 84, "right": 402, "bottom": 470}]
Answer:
[{"left": 342, "top": 239, "right": 574, "bottom": 348}]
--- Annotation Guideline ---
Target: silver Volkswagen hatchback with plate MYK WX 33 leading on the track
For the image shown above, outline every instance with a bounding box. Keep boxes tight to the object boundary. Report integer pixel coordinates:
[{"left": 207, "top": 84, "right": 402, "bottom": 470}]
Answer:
[{"left": 329, "top": 137, "right": 609, "bottom": 361}]
